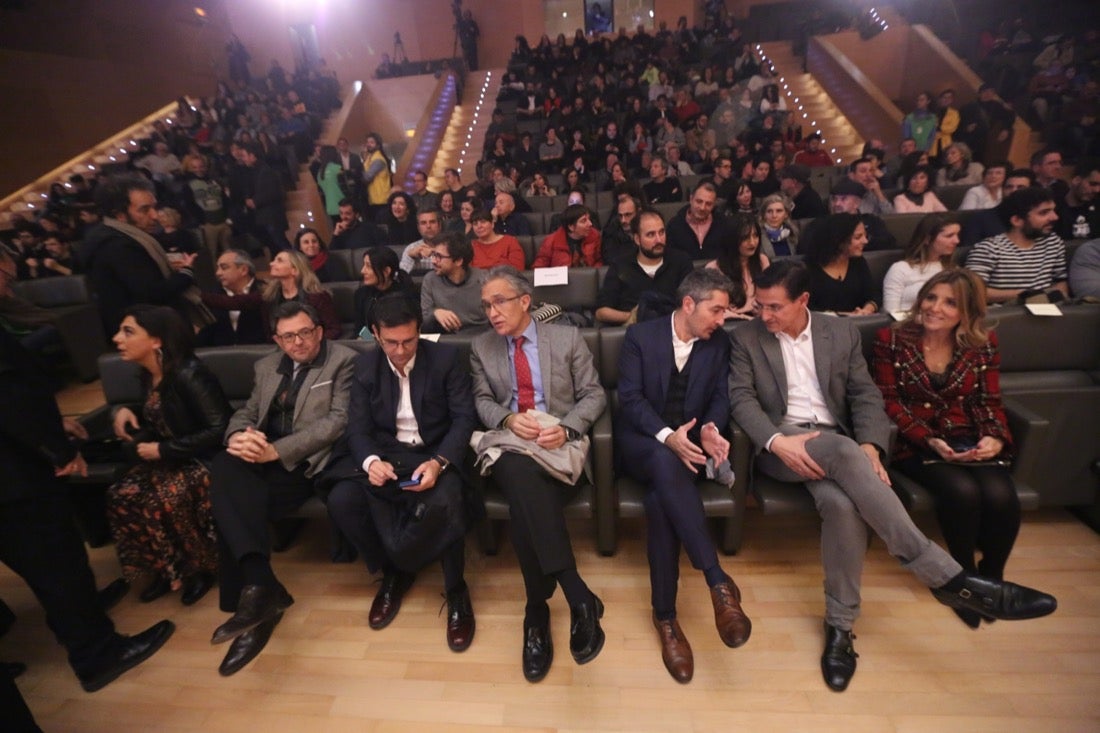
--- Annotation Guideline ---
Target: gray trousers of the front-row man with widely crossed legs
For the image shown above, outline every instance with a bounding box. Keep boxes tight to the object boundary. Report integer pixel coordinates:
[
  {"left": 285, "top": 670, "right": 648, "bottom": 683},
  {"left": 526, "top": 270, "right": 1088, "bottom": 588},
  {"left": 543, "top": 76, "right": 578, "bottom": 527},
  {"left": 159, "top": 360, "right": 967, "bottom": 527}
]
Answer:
[{"left": 756, "top": 425, "right": 963, "bottom": 631}]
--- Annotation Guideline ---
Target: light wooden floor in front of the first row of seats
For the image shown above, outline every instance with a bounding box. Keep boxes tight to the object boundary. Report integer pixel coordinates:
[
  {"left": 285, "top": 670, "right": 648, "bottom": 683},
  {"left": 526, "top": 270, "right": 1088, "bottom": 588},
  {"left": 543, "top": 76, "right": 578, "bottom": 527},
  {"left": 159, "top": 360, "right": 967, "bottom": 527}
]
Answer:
[{"left": 0, "top": 511, "right": 1100, "bottom": 733}]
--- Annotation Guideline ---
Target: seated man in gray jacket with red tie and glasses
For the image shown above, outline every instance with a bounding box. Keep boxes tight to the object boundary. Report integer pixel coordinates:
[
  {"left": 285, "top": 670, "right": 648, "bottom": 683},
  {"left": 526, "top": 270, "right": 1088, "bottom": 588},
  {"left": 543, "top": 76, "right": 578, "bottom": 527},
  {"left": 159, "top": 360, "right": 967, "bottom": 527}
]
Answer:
[{"left": 471, "top": 265, "right": 607, "bottom": 682}]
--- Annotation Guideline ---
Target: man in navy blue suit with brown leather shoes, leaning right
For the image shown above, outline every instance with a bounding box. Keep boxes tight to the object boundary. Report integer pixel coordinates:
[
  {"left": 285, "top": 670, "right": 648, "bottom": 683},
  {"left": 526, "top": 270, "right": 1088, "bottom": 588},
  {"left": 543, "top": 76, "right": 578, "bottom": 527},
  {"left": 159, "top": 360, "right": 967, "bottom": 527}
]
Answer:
[{"left": 615, "top": 269, "right": 752, "bottom": 682}]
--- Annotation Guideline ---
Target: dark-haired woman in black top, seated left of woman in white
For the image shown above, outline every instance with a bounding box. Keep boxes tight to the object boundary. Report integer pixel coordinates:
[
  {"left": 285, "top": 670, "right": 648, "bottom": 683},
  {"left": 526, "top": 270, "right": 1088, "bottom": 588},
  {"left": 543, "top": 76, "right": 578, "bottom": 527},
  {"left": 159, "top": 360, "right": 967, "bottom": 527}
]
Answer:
[{"left": 805, "top": 214, "right": 880, "bottom": 316}]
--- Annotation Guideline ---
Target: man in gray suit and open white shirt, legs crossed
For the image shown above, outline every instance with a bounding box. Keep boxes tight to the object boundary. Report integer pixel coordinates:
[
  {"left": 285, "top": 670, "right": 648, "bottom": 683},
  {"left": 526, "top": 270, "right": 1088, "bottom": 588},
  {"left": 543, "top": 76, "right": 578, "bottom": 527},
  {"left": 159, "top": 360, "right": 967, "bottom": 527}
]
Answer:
[{"left": 729, "top": 260, "right": 1057, "bottom": 691}]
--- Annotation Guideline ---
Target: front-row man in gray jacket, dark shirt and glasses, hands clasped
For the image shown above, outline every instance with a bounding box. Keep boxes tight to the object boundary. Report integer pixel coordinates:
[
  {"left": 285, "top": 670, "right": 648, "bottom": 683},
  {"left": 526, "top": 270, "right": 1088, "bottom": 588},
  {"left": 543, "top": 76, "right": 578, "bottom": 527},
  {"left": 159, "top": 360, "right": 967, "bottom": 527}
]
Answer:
[{"left": 210, "top": 300, "right": 355, "bottom": 677}]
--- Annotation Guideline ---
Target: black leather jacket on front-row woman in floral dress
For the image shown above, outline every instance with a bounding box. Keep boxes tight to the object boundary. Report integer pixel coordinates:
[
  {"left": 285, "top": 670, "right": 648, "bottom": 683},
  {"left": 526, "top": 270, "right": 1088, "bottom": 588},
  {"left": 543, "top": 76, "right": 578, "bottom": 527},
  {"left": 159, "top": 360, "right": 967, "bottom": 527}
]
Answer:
[{"left": 160, "top": 362, "right": 233, "bottom": 460}]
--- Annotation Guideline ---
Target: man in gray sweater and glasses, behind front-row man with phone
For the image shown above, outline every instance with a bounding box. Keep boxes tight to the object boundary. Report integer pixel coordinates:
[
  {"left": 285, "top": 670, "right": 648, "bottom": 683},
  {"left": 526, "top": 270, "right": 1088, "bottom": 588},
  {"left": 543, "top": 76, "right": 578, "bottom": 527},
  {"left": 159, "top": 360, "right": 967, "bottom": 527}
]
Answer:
[{"left": 420, "top": 231, "right": 488, "bottom": 333}]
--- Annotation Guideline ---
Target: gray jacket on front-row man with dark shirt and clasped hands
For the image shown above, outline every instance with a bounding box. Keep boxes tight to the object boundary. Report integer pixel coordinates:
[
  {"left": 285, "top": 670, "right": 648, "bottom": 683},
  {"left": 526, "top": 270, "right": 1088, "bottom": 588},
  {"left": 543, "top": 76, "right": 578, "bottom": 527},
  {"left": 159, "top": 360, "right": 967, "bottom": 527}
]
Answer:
[{"left": 226, "top": 341, "right": 355, "bottom": 477}]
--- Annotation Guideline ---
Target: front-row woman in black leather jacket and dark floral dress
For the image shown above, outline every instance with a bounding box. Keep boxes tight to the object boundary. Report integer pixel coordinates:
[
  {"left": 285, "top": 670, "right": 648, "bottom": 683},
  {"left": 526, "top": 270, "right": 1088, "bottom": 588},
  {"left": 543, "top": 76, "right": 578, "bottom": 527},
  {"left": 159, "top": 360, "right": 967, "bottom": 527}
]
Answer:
[{"left": 107, "top": 306, "right": 232, "bottom": 605}]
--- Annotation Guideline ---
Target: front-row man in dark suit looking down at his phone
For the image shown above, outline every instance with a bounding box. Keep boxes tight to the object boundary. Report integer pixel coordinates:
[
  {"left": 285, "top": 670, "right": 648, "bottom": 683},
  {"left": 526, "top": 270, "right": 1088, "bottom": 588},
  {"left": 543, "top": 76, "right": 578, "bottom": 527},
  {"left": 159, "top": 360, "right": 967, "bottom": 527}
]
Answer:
[{"left": 328, "top": 295, "right": 480, "bottom": 652}]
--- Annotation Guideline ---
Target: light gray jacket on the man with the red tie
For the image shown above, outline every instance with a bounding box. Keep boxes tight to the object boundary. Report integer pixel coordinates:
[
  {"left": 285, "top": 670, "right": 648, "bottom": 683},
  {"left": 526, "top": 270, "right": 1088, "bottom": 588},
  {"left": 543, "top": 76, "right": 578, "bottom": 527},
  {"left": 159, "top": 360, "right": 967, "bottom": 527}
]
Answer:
[{"left": 470, "top": 324, "right": 607, "bottom": 435}]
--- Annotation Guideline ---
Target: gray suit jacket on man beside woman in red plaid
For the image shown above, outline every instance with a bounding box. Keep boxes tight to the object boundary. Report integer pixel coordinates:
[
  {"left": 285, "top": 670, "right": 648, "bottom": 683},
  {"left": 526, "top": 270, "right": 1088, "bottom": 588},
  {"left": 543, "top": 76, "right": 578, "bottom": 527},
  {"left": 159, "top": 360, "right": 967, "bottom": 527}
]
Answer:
[{"left": 729, "top": 313, "right": 890, "bottom": 452}]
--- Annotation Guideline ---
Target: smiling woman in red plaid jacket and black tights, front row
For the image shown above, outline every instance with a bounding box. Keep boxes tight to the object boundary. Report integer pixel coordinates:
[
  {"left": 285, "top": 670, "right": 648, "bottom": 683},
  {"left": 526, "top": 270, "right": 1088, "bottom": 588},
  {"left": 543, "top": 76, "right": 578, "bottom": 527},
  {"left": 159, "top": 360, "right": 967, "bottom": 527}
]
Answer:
[{"left": 873, "top": 269, "right": 1020, "bottom": 628}]
